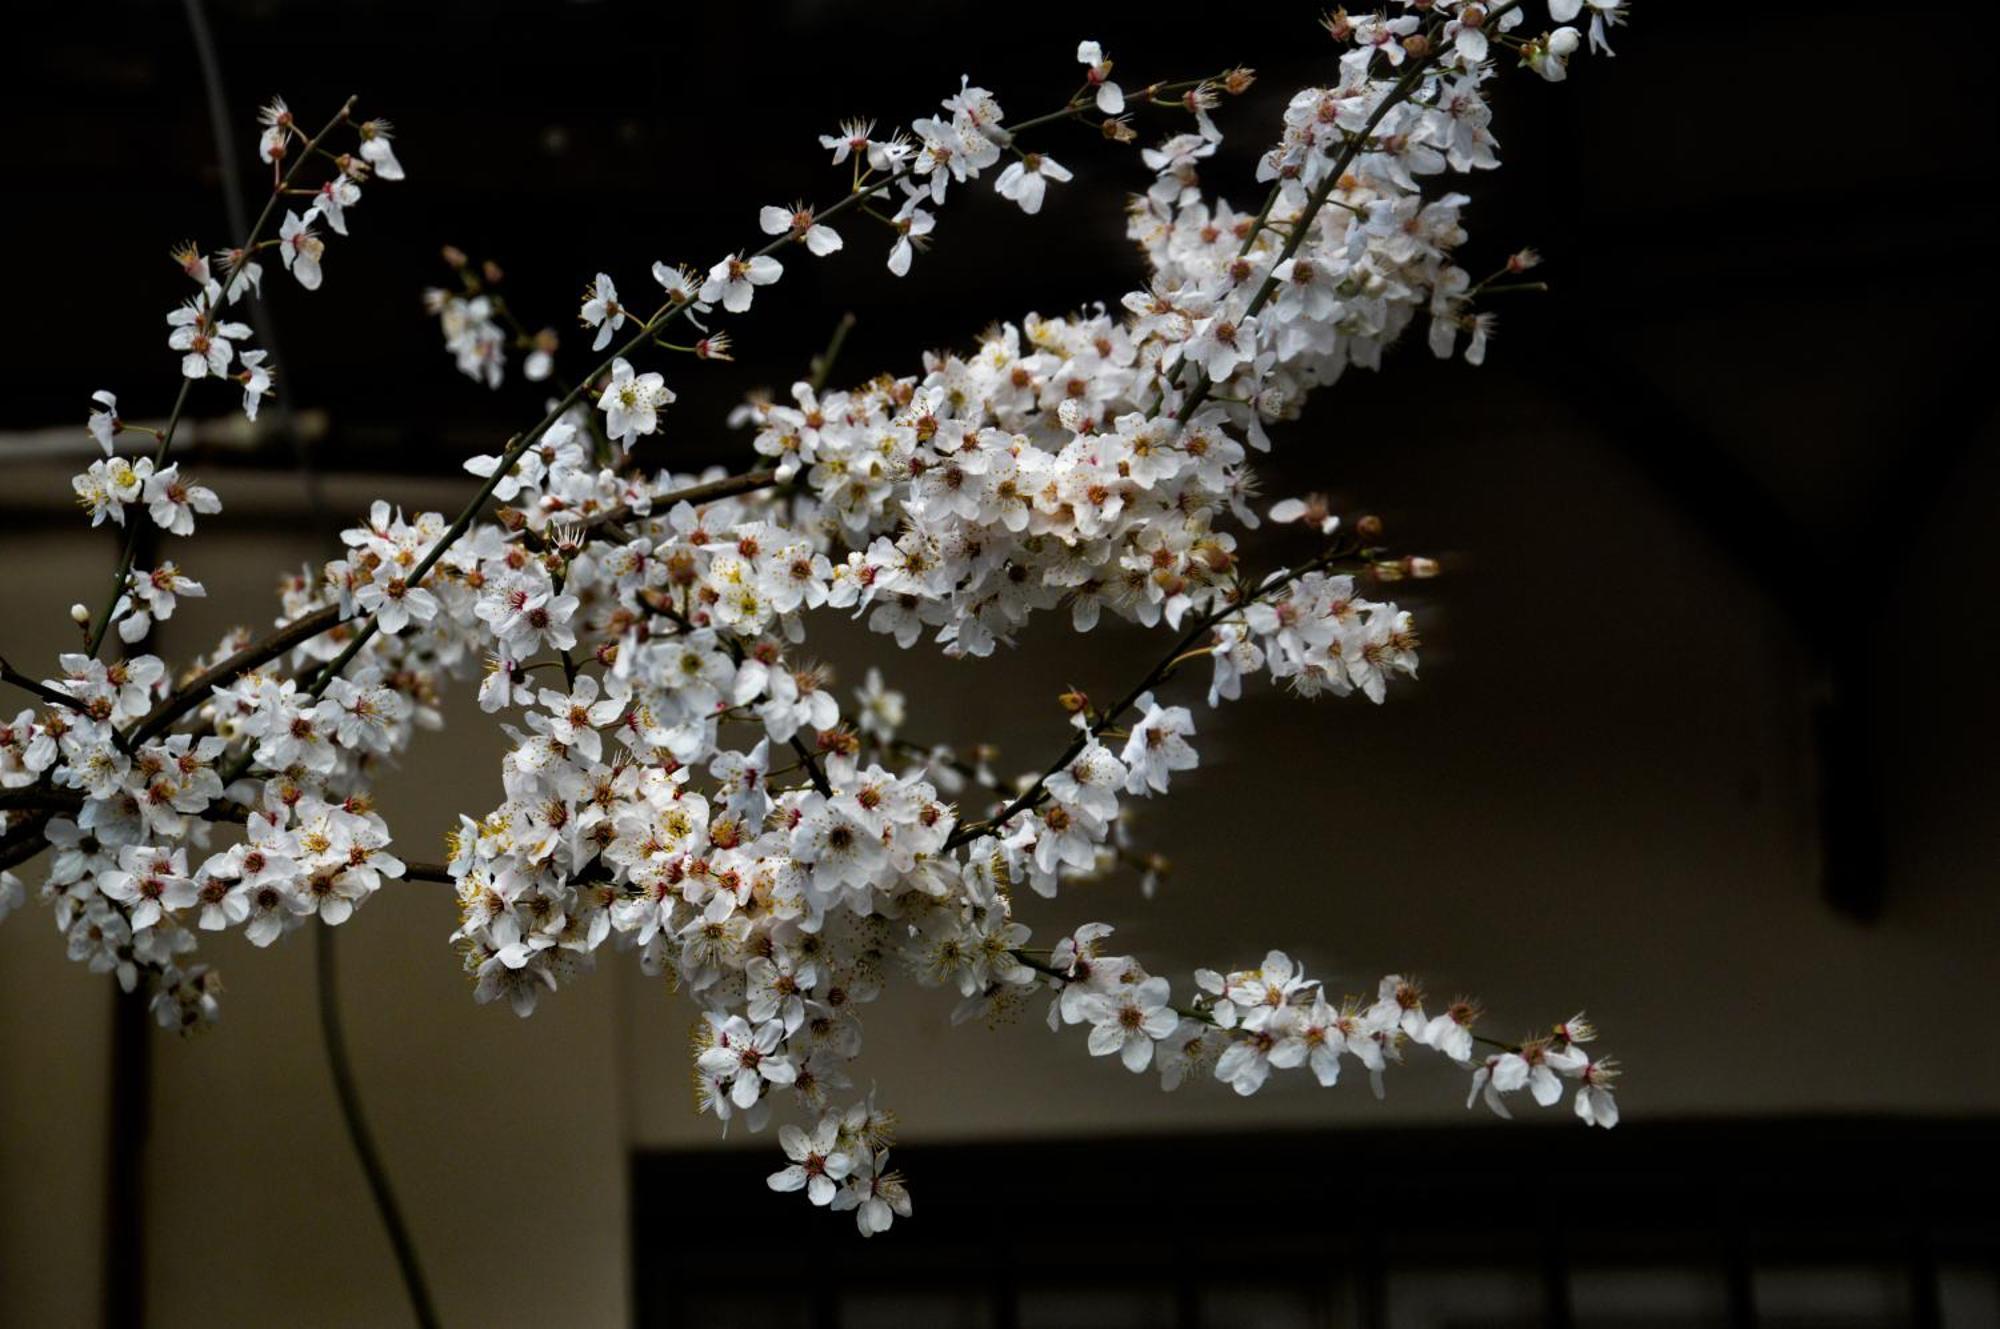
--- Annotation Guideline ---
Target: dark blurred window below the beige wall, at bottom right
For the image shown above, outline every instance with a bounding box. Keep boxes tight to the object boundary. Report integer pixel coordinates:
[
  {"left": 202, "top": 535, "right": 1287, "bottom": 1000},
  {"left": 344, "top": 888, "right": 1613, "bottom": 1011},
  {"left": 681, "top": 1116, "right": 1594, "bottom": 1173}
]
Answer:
[{"left": 632, "top": 1121, "right": 2000, "bottom": 1329}]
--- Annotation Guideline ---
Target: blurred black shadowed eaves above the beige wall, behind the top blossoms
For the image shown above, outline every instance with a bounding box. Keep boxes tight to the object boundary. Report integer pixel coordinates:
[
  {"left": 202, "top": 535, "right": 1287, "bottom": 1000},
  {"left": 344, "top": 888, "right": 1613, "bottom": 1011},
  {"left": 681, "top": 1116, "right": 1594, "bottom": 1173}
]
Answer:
[{"left": 0, "top": 0, "right": 1996, "bottom": 913}]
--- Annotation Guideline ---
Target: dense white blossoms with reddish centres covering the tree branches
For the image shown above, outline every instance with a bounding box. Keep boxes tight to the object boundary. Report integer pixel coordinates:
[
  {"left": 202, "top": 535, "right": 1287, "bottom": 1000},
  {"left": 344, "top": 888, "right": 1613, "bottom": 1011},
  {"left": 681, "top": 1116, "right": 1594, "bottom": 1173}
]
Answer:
[{"left": 0, "top": 0, "right": 1622, "bottom": 1233}]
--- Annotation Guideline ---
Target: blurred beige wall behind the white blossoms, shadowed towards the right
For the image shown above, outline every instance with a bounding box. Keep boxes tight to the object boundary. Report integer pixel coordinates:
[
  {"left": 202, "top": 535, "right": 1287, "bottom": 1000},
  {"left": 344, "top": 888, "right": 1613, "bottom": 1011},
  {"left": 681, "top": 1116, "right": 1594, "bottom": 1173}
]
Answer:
[{"left": 0, "top": 388, "right": 2000, "bottom": 1327}]
